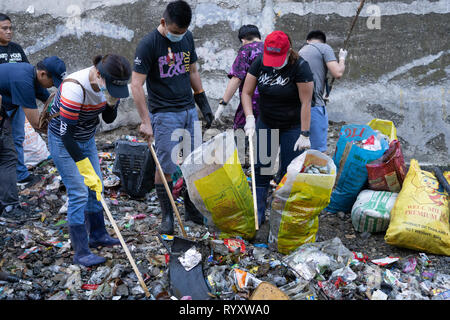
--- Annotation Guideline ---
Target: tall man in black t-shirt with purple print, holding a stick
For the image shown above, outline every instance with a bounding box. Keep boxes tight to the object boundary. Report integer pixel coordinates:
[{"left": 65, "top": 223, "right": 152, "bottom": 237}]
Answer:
[{"left": 131, "top": 1, "right": 213, "bottom": 234}]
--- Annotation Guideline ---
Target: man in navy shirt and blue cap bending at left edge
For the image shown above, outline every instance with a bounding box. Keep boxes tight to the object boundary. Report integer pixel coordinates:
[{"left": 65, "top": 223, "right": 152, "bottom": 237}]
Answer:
[{"left": 0, "top": 56, "right": 66, "bottom": 219}]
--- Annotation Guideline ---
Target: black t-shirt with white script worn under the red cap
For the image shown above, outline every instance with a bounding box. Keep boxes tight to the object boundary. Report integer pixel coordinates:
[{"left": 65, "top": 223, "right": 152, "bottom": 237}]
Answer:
[{"left": 248, "top": 55, "right": 314, "bottom": 129}]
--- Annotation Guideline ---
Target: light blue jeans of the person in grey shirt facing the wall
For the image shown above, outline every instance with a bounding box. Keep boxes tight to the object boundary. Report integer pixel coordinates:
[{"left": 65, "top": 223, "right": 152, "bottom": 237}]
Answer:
[{"left": 309, "top": 106, "right": 328, "bottom": 152}]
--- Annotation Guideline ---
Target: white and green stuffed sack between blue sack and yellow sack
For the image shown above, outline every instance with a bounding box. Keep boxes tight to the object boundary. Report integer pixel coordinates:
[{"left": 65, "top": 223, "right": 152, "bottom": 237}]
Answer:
[{"left": 352, "top": 190, "right": 398, "bottom": 232}]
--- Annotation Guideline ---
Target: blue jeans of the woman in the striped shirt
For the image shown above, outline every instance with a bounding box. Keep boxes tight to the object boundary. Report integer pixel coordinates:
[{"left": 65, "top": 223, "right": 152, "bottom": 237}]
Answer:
[{"left": 48, "top": 130, "right": 103, "bottom": 225}]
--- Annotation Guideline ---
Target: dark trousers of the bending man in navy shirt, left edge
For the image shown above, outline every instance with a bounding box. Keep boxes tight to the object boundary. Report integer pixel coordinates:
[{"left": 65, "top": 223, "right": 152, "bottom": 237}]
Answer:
[{"left": 0, "top": 118, "right": 19, "bottom": 213}]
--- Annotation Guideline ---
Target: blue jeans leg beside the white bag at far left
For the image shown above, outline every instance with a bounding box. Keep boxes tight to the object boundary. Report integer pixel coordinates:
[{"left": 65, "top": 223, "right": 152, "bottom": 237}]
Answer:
[{"left": 11, "top": 107, "right": 30, "bottom": 181}]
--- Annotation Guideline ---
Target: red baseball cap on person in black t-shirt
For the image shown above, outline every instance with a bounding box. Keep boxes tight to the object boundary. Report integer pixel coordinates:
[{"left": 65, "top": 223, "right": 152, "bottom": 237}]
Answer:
[{"left": 263, "top": 31, "right": 291, "bottom": 67}]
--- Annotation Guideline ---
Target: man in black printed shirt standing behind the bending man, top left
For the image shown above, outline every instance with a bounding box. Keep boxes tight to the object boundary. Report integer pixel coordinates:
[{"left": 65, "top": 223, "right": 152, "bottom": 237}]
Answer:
[{"left": 0, "top": 13, "right": 49, "bottom": 186}]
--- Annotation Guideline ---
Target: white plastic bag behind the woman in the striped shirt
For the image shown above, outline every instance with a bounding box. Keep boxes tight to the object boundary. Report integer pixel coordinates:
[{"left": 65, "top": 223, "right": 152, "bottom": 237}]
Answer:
[{"left": 23, "top": 118, "right": 50, "bottom": 168}]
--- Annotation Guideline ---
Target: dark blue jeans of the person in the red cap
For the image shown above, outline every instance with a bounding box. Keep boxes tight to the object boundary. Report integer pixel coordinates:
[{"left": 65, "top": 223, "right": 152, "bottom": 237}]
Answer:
[{"left": 255, "top": 117, "right": 303, "bottom": 187}]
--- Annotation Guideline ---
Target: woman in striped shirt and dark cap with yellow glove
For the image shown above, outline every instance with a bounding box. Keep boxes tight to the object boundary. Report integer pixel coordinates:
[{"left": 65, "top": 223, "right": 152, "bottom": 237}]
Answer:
[{"left": 48, "top": 54, "right": 131, "bottom": 266}]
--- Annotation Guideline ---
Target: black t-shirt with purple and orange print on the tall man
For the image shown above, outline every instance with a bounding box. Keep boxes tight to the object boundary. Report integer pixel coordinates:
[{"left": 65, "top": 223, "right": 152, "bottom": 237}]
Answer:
[{"left": 134, "top": 29, "right": 197, "bottom": 113}]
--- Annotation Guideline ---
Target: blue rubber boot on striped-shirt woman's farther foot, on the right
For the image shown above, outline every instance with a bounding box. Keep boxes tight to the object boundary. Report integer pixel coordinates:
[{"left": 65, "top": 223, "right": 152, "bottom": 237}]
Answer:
[{"left": 84, "top": 211, "right": 120, "bottom": 248}]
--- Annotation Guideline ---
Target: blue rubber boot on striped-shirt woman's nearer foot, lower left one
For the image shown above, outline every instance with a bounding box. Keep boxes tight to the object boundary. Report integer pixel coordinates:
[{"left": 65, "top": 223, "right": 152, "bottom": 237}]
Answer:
[{"left": 69, "top": 224, "right": 106, "bottom": 267}]
